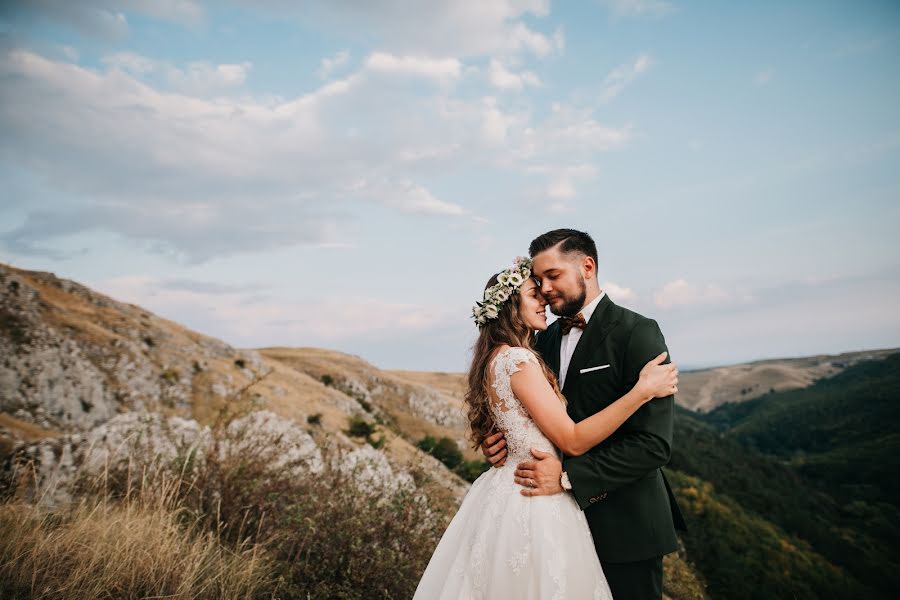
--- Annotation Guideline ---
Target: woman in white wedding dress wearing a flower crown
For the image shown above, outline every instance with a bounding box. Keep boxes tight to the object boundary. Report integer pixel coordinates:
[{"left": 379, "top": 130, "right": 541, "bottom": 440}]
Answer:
[{"left": 414, "top": 257, "right": 678, "bottom": 600}]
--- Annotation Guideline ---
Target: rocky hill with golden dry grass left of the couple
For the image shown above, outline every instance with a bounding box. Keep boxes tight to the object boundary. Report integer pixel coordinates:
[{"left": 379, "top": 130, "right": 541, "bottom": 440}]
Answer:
[{"left": 0, "top": 265, "right": 467, "bottom": 501}]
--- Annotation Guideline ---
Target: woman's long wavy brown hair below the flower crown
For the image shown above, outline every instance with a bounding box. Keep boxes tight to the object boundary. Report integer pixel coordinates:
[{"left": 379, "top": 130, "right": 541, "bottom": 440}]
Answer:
[{"left": 465, "top": 273, "right": 565, "bottom": 449}]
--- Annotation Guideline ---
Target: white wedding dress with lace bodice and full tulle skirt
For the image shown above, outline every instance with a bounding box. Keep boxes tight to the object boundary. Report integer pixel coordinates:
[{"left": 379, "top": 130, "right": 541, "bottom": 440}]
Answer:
[{"left": 414, "top": 348, "right": 612, "bottom": 600}]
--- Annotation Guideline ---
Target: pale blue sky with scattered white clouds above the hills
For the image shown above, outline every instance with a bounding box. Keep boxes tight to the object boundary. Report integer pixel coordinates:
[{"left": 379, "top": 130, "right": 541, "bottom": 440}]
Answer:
[{"left": 0, "top": 0, "right": 900, "bottom": 371}]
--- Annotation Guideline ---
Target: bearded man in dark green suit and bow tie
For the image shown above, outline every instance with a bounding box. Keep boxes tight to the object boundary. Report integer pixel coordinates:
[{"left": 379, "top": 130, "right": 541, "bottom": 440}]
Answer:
[{"left": 481, "top": 229, "right": 685, "bottom": 600}]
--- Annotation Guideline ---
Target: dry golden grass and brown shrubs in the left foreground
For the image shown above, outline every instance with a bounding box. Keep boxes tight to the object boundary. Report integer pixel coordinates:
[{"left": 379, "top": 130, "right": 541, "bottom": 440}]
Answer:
[{"left": 0, "top": 419, "right": 449, "bottom": 600}]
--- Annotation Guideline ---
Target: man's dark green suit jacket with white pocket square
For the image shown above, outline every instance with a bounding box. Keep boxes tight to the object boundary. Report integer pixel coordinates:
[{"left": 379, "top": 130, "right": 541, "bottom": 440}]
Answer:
[{"left": 536, "top": 295, "right": 685, "bottom": 563}]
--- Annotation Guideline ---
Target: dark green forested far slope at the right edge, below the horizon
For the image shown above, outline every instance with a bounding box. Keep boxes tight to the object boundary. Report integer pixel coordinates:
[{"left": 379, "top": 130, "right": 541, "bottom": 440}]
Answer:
[{"left": 705, "top": 353, "right": 900, "bottom": 506}]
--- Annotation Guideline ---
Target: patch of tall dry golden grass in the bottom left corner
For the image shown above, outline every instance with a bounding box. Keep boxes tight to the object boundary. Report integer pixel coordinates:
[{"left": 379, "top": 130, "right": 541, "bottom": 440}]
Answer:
[{"left": 0, "top": 486, "right": 274, "bottom": 599}]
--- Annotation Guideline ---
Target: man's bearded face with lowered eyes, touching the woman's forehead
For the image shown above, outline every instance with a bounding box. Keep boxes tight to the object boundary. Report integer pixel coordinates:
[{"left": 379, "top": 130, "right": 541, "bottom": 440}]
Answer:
[{"left": 532, "top": 246, "right": 587, "bottom": 317}]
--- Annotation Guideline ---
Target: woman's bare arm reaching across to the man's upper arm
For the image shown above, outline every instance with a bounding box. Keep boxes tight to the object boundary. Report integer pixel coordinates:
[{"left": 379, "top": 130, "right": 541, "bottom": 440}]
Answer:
[{"left": 510, "top": 352, "right": 678, "bottom": 456}]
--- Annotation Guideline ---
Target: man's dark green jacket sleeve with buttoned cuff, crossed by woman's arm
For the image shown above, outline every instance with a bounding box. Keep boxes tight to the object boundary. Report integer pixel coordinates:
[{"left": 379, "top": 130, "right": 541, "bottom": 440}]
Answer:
[{"left": 563, "top": 319, "right": 675, "bottom": 510}]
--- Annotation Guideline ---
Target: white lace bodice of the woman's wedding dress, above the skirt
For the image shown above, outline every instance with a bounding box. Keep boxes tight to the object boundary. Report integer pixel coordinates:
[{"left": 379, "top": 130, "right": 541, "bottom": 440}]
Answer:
[{"left": 490, "top": 347, "right": 557, "bottom": 465}]
